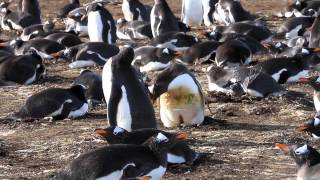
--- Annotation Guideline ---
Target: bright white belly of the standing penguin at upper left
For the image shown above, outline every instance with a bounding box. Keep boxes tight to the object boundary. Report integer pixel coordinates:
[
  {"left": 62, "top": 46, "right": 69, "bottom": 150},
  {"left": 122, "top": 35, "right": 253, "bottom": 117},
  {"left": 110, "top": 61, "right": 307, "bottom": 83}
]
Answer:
[{"left": 88, "top": 12, "right": 103, "bottom": 42}]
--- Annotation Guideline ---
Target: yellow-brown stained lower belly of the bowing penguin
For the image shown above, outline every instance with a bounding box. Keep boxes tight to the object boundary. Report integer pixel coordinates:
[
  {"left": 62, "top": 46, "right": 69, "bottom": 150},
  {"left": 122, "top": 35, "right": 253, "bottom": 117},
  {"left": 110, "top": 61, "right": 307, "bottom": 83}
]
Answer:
[{"left": 160, "top": 88, "right": 204, "bottom": 127}]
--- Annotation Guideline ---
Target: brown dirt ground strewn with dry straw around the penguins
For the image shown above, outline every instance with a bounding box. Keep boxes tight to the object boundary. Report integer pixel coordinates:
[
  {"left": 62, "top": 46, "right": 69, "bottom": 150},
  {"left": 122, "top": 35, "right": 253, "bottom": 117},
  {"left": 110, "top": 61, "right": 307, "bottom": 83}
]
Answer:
[{"left": 0, "top": 0, "right": 320, "bottom": 179}]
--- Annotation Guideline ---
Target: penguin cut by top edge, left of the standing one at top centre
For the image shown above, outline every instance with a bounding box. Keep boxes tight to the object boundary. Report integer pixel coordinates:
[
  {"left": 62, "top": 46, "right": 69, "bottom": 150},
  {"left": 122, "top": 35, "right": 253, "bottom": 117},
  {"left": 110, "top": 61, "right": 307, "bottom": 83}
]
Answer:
[{"left": 122, "top": 0, "right": 150, "bottom": 22}]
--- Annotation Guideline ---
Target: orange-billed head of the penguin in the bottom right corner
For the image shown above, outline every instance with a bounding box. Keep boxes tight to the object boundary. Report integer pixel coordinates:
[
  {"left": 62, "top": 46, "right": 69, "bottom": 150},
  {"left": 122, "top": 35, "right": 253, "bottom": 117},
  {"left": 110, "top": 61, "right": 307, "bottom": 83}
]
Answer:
[{"left": 276, "top": 143, "right": 320, "bottom": 167}]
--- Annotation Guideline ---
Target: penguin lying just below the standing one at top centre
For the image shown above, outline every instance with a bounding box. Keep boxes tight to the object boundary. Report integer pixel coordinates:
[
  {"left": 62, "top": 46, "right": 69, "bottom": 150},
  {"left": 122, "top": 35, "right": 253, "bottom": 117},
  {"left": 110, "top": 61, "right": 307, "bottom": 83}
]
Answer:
[{"left": 149, "top": 32, "right": 199, "bottom": 51}]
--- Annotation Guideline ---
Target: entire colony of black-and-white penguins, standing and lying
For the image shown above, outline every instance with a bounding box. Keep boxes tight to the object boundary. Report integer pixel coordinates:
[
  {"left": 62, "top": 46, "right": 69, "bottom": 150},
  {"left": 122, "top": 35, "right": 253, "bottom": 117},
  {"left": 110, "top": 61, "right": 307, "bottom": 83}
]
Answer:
[{"left": 0, "top": 0, "right": 320, "bottom": 180}]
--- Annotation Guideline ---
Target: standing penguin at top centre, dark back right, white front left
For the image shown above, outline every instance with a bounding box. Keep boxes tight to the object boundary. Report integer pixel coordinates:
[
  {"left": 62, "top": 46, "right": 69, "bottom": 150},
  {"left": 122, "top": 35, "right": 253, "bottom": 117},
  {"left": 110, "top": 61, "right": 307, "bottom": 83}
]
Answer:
[{"left": 150, "top": 0, "right": 180, "bottom": 37}]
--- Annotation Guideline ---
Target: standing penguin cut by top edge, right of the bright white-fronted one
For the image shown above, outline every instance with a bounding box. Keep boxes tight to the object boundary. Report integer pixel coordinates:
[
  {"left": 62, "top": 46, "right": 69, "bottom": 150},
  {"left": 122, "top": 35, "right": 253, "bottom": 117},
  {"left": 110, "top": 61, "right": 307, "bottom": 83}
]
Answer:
[{"left": 214, "top": 0, "right": 255, "bottom": 25}]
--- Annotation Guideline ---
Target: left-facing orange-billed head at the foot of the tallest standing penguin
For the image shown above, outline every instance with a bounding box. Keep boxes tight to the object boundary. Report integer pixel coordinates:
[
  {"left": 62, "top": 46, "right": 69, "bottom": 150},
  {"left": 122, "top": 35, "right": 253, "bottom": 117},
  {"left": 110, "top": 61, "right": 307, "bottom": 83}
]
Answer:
[{"left": 95, "top": 126, "right": 128, "bottom": 144}]
